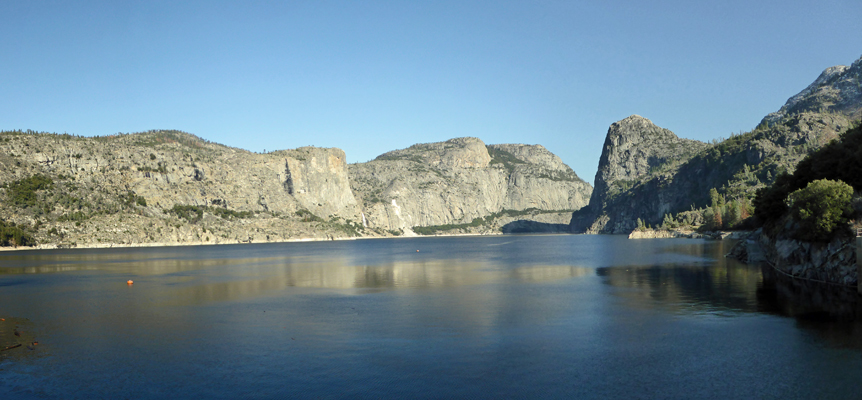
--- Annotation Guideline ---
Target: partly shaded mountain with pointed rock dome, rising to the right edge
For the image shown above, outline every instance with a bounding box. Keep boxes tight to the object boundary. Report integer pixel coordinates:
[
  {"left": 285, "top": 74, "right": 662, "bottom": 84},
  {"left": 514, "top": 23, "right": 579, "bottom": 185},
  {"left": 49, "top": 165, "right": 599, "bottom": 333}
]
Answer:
[{"left": 571, "top": 54, "right": 862, "bottom": 233}]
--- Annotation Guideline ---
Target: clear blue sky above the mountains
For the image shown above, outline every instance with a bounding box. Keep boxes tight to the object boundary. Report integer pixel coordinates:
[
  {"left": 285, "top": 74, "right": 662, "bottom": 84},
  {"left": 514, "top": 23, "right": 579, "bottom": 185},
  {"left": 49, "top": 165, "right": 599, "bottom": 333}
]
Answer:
[{"left": 0, "top": 0, "right": 862, "bottom": 182}]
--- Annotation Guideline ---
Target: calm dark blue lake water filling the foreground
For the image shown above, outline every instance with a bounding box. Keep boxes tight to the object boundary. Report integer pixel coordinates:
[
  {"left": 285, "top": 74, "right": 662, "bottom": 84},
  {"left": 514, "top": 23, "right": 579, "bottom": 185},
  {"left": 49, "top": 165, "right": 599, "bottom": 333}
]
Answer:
[{"left": 0, "top": 236, "right": 862, "bottom": 399}]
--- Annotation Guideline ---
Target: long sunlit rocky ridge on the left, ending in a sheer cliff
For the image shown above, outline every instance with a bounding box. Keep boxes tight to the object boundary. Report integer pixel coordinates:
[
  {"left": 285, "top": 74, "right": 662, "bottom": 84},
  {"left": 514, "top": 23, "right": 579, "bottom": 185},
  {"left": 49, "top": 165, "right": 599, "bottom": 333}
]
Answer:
[{"left": 0, "top": 131, "right": 361, "bottom": 246}]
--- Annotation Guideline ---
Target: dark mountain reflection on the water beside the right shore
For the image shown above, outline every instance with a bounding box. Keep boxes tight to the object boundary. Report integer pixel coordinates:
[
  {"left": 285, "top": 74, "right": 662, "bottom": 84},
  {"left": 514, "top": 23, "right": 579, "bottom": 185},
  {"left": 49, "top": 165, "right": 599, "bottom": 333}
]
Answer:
[{"left": 596, "top": 241, "right": 862, "bottom": 348}]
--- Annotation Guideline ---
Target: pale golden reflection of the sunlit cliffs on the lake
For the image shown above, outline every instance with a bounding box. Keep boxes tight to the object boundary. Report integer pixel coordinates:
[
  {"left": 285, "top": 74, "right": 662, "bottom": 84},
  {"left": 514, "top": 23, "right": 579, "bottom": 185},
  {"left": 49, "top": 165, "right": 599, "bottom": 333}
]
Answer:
[{"left": 0, "top": 244, "right": 594, "bottom": 305}]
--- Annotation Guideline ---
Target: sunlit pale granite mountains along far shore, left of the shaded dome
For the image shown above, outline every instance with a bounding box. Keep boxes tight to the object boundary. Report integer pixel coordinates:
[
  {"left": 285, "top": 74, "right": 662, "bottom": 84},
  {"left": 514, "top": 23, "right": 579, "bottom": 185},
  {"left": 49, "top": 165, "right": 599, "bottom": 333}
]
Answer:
[{"left": 0, "top": 131, "right": 592, "bottom": 247}]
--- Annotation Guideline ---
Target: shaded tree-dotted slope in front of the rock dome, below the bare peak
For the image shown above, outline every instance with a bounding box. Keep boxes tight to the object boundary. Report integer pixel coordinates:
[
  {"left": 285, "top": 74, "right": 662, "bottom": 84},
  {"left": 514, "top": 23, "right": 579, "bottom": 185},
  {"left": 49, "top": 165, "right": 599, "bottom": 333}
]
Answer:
[{"left": 571, "top": 113, "right": 851, "bottom": 234}]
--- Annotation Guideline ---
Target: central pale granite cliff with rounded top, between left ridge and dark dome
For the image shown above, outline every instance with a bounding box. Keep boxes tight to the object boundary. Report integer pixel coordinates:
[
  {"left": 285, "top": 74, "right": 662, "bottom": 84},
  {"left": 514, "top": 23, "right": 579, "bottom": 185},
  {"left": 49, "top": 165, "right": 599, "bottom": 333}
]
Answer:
[{"left": 349, "top": 138, "right": 591, "bottom": 231}]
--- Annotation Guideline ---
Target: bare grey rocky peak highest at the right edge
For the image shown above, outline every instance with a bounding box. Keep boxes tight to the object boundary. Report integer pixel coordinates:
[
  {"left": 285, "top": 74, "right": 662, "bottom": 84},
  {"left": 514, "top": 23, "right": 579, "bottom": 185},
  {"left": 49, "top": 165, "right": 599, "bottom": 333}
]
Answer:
[{"left": 763, "top": 54, "right": 862, "bottom": 125}]
